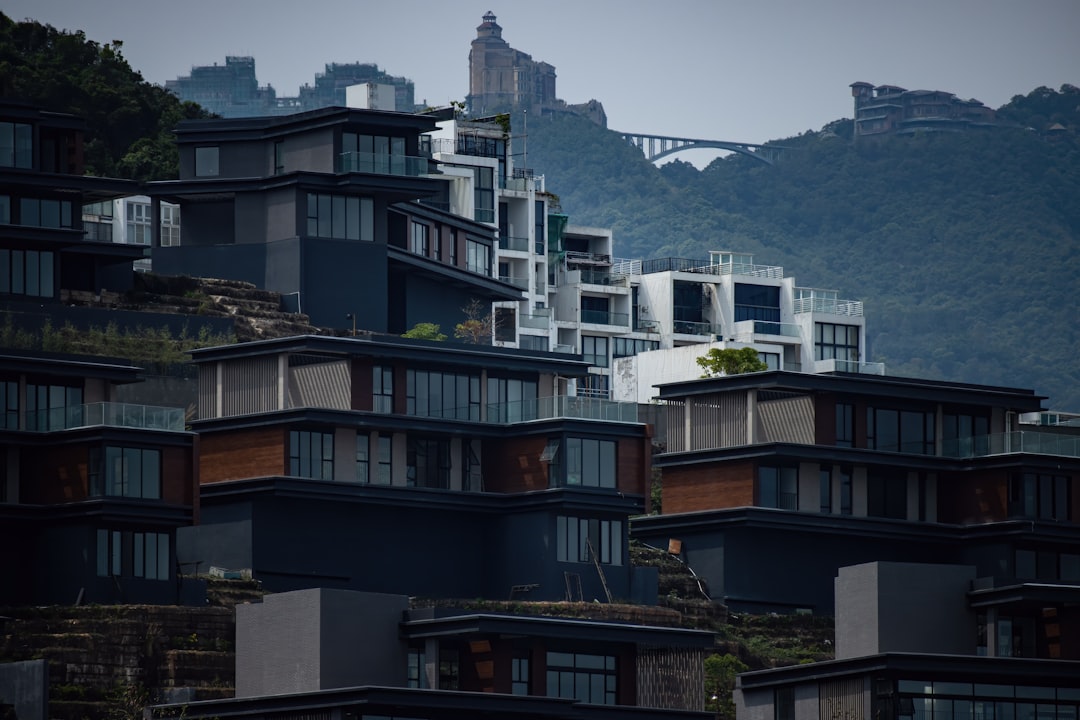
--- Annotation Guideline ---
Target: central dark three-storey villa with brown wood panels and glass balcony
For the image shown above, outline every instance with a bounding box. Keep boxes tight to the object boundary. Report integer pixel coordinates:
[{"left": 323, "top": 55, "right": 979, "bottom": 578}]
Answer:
[{"left": 181, "top": 336, "right": 656, "bottom": 601}]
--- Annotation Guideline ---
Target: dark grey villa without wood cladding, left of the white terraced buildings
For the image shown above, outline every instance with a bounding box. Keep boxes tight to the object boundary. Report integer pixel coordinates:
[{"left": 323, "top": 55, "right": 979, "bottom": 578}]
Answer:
[{"left": 147, "top": 108, "right": 521, "bottom": 332}]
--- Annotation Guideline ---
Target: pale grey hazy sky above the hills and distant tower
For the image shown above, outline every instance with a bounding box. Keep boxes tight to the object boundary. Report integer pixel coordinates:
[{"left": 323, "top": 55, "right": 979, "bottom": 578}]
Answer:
[{"left": 6, "top": 0, "right": 1080, "bottom": 148}]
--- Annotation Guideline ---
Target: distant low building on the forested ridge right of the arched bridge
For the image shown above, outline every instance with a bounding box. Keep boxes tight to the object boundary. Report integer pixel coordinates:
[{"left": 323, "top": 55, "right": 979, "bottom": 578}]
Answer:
[{"left": 850, "top": 82, "right": 995, "bottom": 138}]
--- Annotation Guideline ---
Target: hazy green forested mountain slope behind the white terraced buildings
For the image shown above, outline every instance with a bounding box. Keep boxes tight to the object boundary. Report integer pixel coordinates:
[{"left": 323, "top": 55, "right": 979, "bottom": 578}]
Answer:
[{"left": 515, "top": 85, "right": 1080, "bottom": 411}]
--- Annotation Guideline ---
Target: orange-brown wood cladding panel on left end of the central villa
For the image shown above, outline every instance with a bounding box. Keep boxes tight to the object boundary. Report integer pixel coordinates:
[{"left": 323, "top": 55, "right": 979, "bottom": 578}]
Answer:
[{"left": 199, "top": 427, "right": 287, "bottom": 484}]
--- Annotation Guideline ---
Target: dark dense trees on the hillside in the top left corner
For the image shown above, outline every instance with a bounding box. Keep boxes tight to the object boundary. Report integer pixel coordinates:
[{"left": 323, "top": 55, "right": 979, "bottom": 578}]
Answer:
[{"left": 0, "top": 13, "right": 208, "bottom": 180}]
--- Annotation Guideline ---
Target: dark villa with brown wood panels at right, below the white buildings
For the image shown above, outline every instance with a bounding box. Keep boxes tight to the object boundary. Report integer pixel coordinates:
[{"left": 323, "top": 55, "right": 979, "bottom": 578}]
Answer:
[{"left": 633, "top": 370, "right": 1080, "bottom": 614}]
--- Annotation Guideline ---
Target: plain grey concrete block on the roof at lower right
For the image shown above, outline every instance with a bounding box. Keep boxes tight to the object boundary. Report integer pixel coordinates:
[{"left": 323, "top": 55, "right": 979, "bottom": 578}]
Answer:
[{"left": 836, "top": 562, "right": 975, "bottom": 660}]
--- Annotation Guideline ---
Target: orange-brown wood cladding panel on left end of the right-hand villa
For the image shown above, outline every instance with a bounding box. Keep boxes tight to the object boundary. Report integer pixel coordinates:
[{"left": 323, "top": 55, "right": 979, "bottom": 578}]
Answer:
[{"left": 663, "top": 462, "right": 755, "bottom": 515}]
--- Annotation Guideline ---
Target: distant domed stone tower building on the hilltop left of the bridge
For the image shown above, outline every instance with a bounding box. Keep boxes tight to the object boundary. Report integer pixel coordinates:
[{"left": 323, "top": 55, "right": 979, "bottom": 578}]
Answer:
[{"left": 465, "top": 11, "right": 558, "bottom": 114}]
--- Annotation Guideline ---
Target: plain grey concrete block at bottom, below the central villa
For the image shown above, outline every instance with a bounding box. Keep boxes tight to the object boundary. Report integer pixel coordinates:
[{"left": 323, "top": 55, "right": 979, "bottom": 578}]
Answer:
[{"left": 235, "top": 588, "right": 408, "bottom": 697}]
